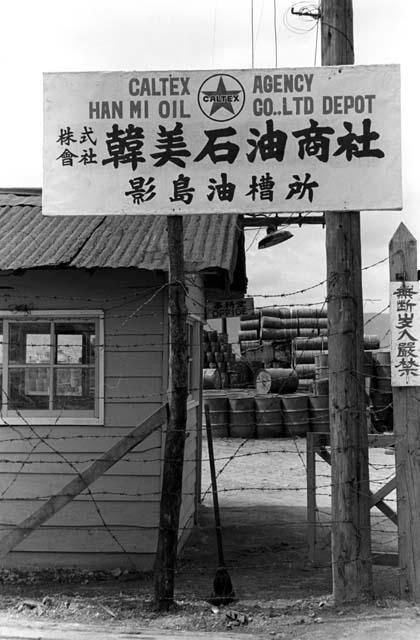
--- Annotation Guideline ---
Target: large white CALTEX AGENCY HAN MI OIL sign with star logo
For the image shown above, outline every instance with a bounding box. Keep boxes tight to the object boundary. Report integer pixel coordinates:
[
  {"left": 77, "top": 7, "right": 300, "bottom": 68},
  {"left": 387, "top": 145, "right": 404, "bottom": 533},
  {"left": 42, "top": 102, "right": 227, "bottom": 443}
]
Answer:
[{"left": 43, "top": 65, "right": 402, "bottom": 215}]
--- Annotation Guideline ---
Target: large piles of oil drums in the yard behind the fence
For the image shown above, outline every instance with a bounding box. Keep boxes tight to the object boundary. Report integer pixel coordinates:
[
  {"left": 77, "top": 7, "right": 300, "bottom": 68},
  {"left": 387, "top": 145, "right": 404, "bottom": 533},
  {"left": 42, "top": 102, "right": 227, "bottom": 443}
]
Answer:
[{"left": 204, "top": 306, "right": 392, "bottom": 438}]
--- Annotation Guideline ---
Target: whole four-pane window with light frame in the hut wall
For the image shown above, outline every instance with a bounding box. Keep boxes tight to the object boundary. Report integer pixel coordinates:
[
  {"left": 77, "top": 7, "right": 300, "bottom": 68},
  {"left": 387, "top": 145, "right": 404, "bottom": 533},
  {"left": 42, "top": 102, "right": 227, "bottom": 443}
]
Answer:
[{"left": 0, "top": 312, "right": 103, "bottom": 423}]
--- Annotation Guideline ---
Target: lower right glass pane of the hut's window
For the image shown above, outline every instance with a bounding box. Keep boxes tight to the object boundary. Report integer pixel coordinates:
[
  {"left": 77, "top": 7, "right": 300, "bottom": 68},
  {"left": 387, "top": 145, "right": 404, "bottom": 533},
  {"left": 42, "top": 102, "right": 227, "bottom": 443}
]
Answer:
[{"left": 53, "top": 367, "right": 95, "bottom": 409}]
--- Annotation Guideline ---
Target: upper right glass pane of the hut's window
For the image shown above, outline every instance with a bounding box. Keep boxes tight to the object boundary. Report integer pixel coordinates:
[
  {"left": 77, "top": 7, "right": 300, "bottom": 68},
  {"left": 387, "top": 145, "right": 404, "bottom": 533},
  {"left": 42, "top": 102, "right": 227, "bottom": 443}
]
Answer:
[{"left": 55, "top": 322, "right": 95, "bottom": 364}]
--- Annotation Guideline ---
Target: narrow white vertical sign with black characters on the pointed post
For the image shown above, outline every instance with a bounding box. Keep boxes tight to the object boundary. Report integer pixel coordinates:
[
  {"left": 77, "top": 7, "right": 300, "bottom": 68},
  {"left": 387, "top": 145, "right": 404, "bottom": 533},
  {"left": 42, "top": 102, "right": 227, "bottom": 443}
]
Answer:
[{"left": 390, "top": 281, "right": 420, "bottom": 387}]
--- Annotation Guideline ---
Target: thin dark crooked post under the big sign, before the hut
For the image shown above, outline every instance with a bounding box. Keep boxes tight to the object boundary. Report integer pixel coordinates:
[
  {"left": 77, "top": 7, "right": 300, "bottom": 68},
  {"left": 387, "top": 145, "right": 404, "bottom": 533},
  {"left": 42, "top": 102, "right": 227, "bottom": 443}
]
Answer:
[{"left": 155, "top": 215, "right": 188, "bottom": 611}]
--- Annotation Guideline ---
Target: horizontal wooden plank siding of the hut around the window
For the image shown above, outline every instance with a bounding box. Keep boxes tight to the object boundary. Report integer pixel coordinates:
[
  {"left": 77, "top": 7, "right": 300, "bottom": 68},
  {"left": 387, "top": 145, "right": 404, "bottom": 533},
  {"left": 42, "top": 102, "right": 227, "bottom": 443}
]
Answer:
[{"left": 0, "top": 269, "right": 203, "bottom": 570}]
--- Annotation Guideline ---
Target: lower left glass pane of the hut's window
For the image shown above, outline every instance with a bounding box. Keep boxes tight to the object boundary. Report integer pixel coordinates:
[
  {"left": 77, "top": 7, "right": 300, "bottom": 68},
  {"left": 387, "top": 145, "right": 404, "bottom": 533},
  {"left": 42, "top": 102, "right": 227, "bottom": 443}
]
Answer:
[{"left": 8, "top": 367, "right": 50, "bottom": 409}]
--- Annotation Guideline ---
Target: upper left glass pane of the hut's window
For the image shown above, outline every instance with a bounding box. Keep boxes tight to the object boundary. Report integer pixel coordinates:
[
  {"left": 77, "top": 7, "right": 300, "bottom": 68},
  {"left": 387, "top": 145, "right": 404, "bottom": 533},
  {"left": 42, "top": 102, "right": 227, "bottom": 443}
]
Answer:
[{"left": 9, "top": 322, "right": 51, "bottom": 364}]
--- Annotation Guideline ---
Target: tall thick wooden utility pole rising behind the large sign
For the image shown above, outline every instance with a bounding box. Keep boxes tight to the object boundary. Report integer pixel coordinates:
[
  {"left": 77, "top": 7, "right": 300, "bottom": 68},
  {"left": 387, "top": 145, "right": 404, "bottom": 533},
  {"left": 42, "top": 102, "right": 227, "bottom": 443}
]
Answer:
[{"left": 321, "top": 0, "right": 373, "bottom": 604}]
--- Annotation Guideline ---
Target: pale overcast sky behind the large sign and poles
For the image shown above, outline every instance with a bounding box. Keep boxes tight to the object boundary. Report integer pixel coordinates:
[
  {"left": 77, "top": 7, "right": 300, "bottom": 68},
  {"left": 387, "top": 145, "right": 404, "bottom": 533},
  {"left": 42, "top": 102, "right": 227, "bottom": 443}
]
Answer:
[{"left": 0, "top": 0, "right": 414, "bottom": 313}]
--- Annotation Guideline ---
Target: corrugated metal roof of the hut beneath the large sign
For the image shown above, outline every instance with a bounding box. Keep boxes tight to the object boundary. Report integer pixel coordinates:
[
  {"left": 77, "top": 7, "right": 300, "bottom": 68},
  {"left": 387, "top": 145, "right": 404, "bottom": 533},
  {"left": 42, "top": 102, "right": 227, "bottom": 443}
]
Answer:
[{"left": 0, "top": 189, "right": 241, "bottom": 275}]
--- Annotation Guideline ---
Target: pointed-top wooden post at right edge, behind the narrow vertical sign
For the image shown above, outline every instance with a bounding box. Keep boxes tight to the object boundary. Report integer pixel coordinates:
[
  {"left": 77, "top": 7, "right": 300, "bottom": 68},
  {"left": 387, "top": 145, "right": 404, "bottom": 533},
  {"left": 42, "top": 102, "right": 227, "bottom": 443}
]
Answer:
[{"left": 389, "top": 223, "right": 420, "bottom": 603}]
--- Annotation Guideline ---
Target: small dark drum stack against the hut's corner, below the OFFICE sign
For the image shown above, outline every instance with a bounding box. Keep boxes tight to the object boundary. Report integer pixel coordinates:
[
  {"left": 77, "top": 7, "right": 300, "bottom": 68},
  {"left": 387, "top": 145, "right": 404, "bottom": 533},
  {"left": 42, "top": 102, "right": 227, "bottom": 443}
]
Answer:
[{"left": 203, "top": 331, "right": 236, "bottom": 389}]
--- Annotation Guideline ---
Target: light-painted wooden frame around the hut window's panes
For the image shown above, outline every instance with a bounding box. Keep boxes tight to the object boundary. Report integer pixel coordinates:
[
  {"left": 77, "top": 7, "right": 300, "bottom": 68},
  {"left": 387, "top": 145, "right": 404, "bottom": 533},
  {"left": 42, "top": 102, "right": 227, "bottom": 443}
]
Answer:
[{"left": 0, "top": 309, "right": 105, "bottom": 425}]
